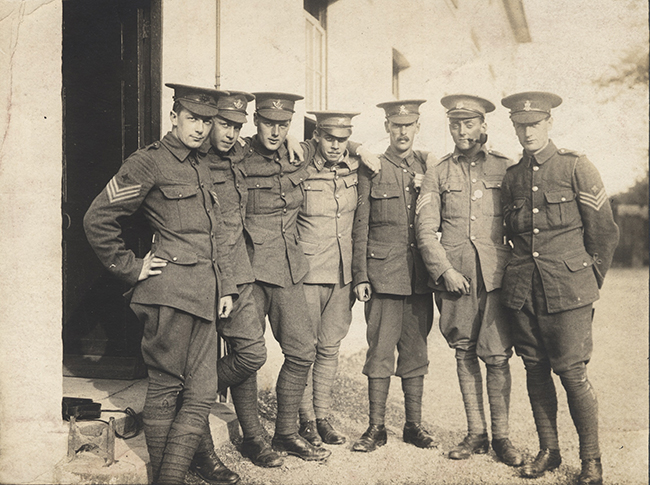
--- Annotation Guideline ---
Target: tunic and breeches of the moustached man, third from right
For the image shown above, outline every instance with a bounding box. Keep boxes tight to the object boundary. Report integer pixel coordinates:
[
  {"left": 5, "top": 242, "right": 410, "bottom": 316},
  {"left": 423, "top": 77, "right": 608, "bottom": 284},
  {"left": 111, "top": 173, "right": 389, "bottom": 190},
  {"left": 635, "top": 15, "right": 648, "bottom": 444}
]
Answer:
[{"left": 352, "top": 147, "right": 433, "bottom": 378}]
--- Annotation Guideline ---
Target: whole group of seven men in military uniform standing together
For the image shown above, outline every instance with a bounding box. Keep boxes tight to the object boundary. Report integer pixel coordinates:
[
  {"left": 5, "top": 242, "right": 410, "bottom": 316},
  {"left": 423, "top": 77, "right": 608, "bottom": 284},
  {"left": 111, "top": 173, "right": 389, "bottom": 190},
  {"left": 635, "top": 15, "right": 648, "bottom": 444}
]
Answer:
[{"left": 84, "top": 84, "right": 618, "bottom": 485}]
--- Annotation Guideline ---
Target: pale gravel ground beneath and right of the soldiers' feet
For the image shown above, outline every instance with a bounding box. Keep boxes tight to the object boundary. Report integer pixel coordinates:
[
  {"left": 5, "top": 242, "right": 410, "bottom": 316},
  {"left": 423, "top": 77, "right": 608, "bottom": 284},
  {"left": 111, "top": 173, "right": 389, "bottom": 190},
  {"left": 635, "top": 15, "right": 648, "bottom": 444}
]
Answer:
[{"left": 211, "top": 268, "right": 648, "bottom": 485}]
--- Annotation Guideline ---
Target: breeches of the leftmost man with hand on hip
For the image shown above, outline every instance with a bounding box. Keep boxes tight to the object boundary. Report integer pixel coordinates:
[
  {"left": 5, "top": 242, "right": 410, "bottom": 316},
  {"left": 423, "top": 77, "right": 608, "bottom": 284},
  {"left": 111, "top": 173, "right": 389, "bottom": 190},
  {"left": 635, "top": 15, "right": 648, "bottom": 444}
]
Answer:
[{"left": 131, "top": 303, "right": 217, "bottom": 429}]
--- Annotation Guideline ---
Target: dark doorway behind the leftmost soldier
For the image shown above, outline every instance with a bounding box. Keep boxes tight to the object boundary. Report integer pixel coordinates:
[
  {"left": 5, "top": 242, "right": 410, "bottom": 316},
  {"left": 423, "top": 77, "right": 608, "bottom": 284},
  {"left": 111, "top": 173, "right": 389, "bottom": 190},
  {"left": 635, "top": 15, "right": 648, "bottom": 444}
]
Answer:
[{"left": 62, "top": 0, "right": 160, "bottom": 379}]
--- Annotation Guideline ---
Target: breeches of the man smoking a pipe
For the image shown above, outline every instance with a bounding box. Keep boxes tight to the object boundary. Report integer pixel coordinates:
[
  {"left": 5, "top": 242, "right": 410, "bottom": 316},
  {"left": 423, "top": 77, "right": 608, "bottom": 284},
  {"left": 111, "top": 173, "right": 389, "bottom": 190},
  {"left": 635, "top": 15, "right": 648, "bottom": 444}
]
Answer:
[{"left": 435, "top": 271, "right": 512, "bottom": 364}]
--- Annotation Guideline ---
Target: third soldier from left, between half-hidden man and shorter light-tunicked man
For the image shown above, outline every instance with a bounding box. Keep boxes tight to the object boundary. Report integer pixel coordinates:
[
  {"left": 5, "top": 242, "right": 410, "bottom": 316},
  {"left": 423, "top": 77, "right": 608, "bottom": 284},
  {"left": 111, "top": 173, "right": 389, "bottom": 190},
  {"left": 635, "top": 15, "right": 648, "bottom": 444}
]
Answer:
[{"left": 240, "top": 92, "right": 331, "bottom": 461}]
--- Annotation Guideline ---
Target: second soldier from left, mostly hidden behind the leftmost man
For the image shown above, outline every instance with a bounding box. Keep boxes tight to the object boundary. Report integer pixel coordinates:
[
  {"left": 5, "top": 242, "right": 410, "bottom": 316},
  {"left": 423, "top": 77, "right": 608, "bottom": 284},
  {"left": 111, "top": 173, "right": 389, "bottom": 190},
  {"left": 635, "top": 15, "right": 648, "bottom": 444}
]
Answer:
[{"left": 208, "top": 91, "right": 283, "bottom": 467}]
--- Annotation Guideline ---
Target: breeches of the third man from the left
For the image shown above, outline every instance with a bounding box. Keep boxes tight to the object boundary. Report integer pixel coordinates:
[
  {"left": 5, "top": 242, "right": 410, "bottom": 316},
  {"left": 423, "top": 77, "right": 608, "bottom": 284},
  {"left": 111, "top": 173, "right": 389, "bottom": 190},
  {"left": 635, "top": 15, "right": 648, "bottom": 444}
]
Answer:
[{"left": 253, "top": 281, "right": 316, "bottom": 366}]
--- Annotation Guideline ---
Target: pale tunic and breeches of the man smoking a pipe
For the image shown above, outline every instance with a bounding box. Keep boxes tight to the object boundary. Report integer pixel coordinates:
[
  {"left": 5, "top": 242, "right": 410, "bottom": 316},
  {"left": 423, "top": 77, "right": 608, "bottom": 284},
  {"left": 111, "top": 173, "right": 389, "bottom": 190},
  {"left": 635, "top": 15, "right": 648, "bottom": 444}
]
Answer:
[{"left": 416, "top": 146, "right": 512, "bottom": 360}]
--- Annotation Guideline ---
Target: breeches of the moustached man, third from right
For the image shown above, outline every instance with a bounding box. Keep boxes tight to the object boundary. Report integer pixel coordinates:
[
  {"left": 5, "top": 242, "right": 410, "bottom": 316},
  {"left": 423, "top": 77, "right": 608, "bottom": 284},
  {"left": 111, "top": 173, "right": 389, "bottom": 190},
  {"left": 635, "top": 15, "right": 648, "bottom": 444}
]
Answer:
[{"left": 363, "top": 293, "right": 433, "bottom": 378}]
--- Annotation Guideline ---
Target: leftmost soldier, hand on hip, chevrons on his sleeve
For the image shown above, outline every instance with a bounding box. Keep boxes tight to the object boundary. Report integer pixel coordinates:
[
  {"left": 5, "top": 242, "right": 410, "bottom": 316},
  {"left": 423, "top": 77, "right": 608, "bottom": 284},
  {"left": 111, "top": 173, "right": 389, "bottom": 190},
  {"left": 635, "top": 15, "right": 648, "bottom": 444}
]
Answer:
[{"left": 84, "top": 84, "right": 239, "bottom": 484}]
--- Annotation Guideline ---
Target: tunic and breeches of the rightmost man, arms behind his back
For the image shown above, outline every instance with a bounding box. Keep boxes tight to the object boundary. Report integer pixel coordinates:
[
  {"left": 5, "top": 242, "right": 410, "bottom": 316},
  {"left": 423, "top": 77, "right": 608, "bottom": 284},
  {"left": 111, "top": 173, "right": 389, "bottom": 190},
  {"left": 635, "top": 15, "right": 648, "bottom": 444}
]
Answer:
[{"left": 502, "top": 141, "right": 619, "bottom": 372}]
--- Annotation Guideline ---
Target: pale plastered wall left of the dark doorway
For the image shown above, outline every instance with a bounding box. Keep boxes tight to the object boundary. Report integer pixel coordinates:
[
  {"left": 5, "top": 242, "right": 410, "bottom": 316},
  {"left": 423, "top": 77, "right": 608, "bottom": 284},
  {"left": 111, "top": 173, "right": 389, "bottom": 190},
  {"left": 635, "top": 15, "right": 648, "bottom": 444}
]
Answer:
[{"left": 0, "top": 0, "right": 67, "bottom": 483}]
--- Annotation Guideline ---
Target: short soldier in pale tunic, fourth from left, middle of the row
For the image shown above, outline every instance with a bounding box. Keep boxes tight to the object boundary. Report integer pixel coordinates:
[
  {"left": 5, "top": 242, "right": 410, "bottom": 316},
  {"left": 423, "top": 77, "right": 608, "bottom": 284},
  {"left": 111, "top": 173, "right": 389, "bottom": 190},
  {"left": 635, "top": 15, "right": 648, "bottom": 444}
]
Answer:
[{"left": 298, "top": 111, "right": 359, "bottom": 445}]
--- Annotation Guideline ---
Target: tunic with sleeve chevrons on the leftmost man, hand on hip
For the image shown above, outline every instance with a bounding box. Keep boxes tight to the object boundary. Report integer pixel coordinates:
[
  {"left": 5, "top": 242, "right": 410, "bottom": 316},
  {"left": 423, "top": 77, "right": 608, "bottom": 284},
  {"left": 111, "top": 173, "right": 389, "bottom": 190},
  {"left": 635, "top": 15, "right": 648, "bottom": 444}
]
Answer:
[{"left": 84, "top": 133, "right": 237, "bottom": 320}]
